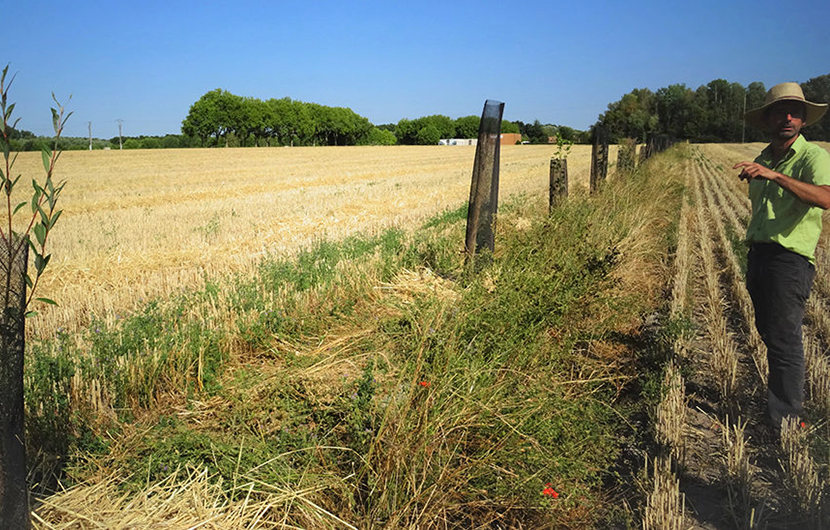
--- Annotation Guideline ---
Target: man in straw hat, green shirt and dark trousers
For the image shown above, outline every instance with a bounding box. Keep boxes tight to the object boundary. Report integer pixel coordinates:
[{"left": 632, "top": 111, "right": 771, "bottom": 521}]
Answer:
[{"left": 733, "top": 83, "right": 830, "bottom": 433}]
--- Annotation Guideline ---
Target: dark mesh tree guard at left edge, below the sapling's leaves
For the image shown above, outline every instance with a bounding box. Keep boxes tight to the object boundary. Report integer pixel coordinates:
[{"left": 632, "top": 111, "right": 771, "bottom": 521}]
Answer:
[{"left": 0, "top": 238, "right": 29, "bottom": 529}]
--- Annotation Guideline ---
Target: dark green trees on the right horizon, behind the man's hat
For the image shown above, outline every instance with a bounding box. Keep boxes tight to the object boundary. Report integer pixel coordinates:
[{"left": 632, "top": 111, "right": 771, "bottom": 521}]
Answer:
[{"left": 595, "top": 74, "right": 830, "bottom": 142}]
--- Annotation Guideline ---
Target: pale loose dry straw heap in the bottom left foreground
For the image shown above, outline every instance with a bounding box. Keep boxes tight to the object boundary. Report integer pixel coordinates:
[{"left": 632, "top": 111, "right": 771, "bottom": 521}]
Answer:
[{"left": 32, "top": 462, "right": 356, "bottom": 530}]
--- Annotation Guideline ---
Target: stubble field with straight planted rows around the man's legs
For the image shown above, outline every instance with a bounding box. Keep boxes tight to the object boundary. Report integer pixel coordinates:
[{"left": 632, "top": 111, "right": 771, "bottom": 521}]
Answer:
[{"left": 655, "top": 143, "right": 830, "bottom": 529}]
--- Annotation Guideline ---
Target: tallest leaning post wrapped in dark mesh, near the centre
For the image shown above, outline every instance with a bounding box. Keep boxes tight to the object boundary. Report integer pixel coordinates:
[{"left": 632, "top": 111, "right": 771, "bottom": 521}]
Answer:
[{"left": 464, "top": 99, "right": 504, "bottom": 263}]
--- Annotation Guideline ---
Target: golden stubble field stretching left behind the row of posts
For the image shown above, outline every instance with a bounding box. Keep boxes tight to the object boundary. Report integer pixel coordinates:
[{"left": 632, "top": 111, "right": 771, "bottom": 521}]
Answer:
[{"left": 9, "top": 142, "right": 616, "bottom": 336}]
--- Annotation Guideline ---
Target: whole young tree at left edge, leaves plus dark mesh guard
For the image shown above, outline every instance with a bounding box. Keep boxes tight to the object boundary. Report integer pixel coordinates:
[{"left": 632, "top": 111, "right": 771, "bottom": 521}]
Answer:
[{"left": 0, "top": 65, "right": 71, "bottom": 528}]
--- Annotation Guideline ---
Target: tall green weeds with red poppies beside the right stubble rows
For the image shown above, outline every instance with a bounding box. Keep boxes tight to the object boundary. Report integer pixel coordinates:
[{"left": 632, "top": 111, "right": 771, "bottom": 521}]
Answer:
[{"left": 342, "top": 147, "right": 681, "bottom": 527}]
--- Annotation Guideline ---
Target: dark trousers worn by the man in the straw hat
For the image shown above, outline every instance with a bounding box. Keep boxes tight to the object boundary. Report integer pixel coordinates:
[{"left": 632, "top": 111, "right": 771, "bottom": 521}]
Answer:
[{"left": 746, "top": 243, "right": 816, "bottom": 426}]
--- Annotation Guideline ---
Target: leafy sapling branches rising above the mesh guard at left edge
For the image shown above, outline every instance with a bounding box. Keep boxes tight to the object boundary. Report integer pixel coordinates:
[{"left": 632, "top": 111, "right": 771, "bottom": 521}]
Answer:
[{"left": 0, "top": 65, "right": 72, "bottom": 314}]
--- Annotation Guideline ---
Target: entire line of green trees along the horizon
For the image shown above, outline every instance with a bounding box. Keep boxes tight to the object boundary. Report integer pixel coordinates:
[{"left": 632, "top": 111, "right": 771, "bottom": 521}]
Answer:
[{"left": 11, "top": 74, "right": 830, "bottom": 151}]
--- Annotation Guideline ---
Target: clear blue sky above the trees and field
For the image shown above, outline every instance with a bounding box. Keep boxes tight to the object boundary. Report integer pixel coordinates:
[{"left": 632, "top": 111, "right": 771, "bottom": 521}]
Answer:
[{"left": 6, "top": 0, "right": 830, "bottom": 138}]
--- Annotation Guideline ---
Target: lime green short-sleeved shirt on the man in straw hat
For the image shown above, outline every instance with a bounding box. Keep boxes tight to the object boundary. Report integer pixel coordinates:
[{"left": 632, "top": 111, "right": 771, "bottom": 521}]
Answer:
[{"left": 746, "top": 135, "right": 830, "bottom": 263}]
